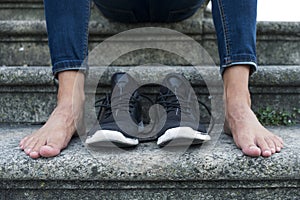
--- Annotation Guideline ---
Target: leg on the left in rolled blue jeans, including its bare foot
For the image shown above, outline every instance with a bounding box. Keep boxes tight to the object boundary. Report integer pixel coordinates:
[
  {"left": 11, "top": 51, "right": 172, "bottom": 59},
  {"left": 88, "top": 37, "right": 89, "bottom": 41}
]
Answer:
[{"left": 20, "top": 0, "right": 90, "bottom": 158}]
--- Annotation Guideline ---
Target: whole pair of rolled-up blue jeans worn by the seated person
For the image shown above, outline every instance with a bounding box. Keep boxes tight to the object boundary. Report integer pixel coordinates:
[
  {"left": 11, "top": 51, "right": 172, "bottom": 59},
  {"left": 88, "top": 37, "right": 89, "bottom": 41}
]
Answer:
[{"left": 44, "top": 0, "right": 257, "bottom": 76}]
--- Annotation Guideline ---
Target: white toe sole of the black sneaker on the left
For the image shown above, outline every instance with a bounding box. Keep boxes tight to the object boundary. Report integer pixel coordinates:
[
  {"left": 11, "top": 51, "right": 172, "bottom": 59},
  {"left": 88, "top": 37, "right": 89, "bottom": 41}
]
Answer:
[{"left": 85, "top": 130, "right": 139, "bottom": 147}]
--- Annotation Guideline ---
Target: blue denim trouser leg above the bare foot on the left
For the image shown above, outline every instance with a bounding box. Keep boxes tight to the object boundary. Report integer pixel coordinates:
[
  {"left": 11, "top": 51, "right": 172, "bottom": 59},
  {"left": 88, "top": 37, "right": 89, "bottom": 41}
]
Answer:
[{"left": 44, "top": 0, "right": 90, "bottom": 76}]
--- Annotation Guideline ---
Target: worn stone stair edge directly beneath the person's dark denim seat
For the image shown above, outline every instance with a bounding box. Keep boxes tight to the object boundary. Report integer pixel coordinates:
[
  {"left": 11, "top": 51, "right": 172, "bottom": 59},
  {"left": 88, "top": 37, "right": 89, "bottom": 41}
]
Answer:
[{"left": 0, "top": 18, "right": 300, "bottom": 38}]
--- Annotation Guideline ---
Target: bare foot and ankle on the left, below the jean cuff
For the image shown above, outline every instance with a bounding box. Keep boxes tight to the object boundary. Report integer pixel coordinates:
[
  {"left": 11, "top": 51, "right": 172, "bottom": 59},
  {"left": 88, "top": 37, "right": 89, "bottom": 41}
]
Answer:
[{"left": 19, "top": 71, "right": 84, "bottom": 158}]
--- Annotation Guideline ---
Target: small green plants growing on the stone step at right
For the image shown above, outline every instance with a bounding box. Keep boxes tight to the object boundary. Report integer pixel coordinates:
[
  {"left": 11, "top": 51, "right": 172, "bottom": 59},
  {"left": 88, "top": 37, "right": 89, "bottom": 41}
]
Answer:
[{"left": 255, "top": 106, "right": 300, "bottom": 126}]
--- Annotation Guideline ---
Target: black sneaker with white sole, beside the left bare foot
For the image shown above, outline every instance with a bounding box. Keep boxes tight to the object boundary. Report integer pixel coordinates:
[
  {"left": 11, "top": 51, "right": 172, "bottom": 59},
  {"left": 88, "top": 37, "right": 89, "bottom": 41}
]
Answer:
[{"left": 86, "top": 73, "right": 142, "bottom": 147}]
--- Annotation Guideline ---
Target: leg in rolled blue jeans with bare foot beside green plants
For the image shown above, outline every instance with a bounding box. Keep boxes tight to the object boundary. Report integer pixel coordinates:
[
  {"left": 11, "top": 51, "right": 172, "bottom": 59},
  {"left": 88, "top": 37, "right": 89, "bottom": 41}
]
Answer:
[{"left": 213, "top": 0, "right": 283, "bottom": 157}]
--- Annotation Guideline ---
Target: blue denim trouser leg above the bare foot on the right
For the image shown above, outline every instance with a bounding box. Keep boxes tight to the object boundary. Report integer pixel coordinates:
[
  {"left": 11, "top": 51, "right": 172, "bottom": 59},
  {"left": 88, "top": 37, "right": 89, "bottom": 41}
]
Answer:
[{"left": 212, "top": 0, "right": 257, "bottom": 74}]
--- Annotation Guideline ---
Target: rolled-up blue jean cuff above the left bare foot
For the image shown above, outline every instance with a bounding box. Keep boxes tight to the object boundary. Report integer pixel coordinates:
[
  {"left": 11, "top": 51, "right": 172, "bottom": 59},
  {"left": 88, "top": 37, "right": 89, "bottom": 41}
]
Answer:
[{"left": 52, "top": 60, "right": 88, "bottom": 78}]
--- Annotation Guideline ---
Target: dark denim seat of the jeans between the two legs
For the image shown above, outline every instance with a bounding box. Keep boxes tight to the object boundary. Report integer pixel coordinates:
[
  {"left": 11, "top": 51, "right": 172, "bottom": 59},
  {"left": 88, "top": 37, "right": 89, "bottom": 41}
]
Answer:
[{"left": 94, "top": 0, "right": 204, "bottom": 23}]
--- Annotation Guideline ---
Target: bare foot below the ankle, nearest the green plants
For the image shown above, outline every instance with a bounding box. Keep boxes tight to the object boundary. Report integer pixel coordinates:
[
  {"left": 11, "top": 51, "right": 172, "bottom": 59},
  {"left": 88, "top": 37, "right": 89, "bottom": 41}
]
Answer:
[{"left": 226, "top": 101, "right": 283, "bottom": 157}]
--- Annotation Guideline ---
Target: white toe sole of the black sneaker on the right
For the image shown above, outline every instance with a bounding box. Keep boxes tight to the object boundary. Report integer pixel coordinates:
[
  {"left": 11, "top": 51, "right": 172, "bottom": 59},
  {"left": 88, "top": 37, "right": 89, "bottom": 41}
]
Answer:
[{"left": 157, "top": 127, "right": 211, "bottom": 147}]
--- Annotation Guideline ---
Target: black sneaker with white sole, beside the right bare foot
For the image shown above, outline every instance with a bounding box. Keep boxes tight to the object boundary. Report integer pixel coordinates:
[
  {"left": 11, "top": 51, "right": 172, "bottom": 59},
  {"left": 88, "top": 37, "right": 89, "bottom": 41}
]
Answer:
[{"left": 156, "top": 73, "right": 210, "bottom": 147}]
